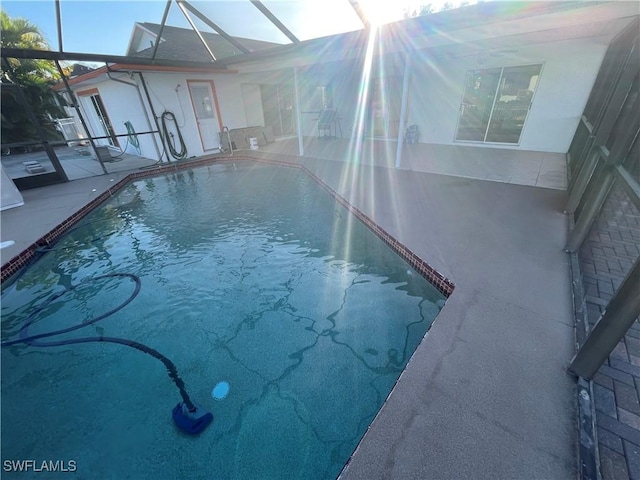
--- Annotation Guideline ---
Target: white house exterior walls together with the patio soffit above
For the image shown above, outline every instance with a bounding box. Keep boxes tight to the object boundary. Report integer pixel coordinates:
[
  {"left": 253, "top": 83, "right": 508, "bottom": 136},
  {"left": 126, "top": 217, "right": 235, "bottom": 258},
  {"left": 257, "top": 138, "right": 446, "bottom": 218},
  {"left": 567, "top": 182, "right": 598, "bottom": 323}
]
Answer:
[{"left": 61, "top": 2, "right": 637, "bottom": 165}]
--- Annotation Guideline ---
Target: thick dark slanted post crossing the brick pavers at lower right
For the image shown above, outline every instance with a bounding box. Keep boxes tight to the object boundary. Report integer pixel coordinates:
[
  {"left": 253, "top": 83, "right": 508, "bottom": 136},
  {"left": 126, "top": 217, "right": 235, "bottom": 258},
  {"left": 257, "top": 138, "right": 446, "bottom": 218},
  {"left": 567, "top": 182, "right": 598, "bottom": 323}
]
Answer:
[{"left": 569, "top": 260, "right": 640, "bottom": 379}]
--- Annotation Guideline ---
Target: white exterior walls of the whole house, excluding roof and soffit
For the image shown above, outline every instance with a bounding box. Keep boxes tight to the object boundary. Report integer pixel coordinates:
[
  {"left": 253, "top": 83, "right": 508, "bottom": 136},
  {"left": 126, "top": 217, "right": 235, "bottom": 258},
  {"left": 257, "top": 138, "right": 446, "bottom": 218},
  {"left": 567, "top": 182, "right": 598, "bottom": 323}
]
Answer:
[{"left": 65, "top": 32, "right": 608, "bottom": 159}]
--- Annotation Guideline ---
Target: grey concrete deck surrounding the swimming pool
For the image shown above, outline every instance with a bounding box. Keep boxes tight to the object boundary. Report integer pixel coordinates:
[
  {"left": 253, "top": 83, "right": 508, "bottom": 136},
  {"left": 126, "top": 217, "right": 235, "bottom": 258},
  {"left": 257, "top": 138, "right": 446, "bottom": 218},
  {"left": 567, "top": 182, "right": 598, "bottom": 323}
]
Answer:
[{"left": 0, "top": 143, "right": 578, "bottom": 480}]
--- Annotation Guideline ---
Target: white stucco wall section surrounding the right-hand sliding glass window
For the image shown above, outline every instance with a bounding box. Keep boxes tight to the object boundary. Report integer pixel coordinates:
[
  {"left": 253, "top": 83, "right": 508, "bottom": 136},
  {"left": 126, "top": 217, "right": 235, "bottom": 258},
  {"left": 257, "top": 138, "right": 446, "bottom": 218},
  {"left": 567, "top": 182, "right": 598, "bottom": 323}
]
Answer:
[{"left": 408, "top": 35, "right": 606, "bottom": 153}]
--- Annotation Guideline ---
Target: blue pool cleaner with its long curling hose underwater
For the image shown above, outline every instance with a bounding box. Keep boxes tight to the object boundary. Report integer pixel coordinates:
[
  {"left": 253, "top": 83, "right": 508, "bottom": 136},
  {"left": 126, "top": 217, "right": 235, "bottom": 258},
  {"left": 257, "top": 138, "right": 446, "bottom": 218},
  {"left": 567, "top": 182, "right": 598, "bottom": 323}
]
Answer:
[{"left": 0, "top": 273, "right": 213, "bottom": 435}]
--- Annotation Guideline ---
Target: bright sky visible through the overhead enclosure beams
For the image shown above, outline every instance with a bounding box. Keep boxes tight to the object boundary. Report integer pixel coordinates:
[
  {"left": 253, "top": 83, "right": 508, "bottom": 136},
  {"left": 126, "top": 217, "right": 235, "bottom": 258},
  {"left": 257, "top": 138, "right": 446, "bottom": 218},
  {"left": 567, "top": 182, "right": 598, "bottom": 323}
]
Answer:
[{"left": 1, "top": 0, "right": 474, "bottom": 55}]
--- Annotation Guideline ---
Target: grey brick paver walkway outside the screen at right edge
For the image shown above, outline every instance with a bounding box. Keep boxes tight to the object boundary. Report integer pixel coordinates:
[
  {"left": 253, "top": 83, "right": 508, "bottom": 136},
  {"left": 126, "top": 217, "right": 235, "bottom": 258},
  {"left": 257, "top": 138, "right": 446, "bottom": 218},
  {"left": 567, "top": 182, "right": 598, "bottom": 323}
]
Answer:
[{"left": 579, "top": 180, "right": 640, "bottom": 480}]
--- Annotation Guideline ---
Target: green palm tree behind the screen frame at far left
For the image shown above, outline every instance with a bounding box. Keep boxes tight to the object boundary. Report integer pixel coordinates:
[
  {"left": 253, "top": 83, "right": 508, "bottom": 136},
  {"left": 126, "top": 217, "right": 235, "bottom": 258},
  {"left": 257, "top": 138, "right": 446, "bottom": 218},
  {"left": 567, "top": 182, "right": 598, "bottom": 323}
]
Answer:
[{"left": 0, "top": 11, "right": 66, "bottom": 144}]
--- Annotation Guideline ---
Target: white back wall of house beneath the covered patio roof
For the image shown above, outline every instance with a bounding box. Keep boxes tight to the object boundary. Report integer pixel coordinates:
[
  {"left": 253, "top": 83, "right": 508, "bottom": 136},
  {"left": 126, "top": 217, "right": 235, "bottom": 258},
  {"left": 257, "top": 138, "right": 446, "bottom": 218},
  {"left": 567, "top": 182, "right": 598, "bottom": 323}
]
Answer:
[{"left": 235, "top": 36, "right": 610, "bottom": 153}]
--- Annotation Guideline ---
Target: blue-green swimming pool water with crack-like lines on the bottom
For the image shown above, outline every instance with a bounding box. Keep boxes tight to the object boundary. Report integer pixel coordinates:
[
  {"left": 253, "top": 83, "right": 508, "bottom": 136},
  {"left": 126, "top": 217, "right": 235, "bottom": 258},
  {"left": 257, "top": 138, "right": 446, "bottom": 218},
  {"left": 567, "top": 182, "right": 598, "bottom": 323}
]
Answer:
[{"left": 1, "top": 162, "right": 444, "bottom": 479}]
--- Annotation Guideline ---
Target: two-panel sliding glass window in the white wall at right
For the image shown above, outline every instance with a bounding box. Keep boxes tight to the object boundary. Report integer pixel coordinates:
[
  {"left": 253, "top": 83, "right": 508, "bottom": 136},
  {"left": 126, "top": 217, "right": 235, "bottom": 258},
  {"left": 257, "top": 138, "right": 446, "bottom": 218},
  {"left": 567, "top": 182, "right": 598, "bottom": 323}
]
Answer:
[{"left": 456, "top": 65, "right": 542, "bottom": 144}]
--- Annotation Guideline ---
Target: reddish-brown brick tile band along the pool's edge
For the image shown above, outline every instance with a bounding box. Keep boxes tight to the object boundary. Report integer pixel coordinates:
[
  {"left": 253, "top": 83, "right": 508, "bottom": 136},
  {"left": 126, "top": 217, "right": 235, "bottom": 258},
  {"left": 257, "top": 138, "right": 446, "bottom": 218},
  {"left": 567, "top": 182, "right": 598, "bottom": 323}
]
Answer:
[{"left": 0, "top": 155, "right": 455, "bottom": 298}]
